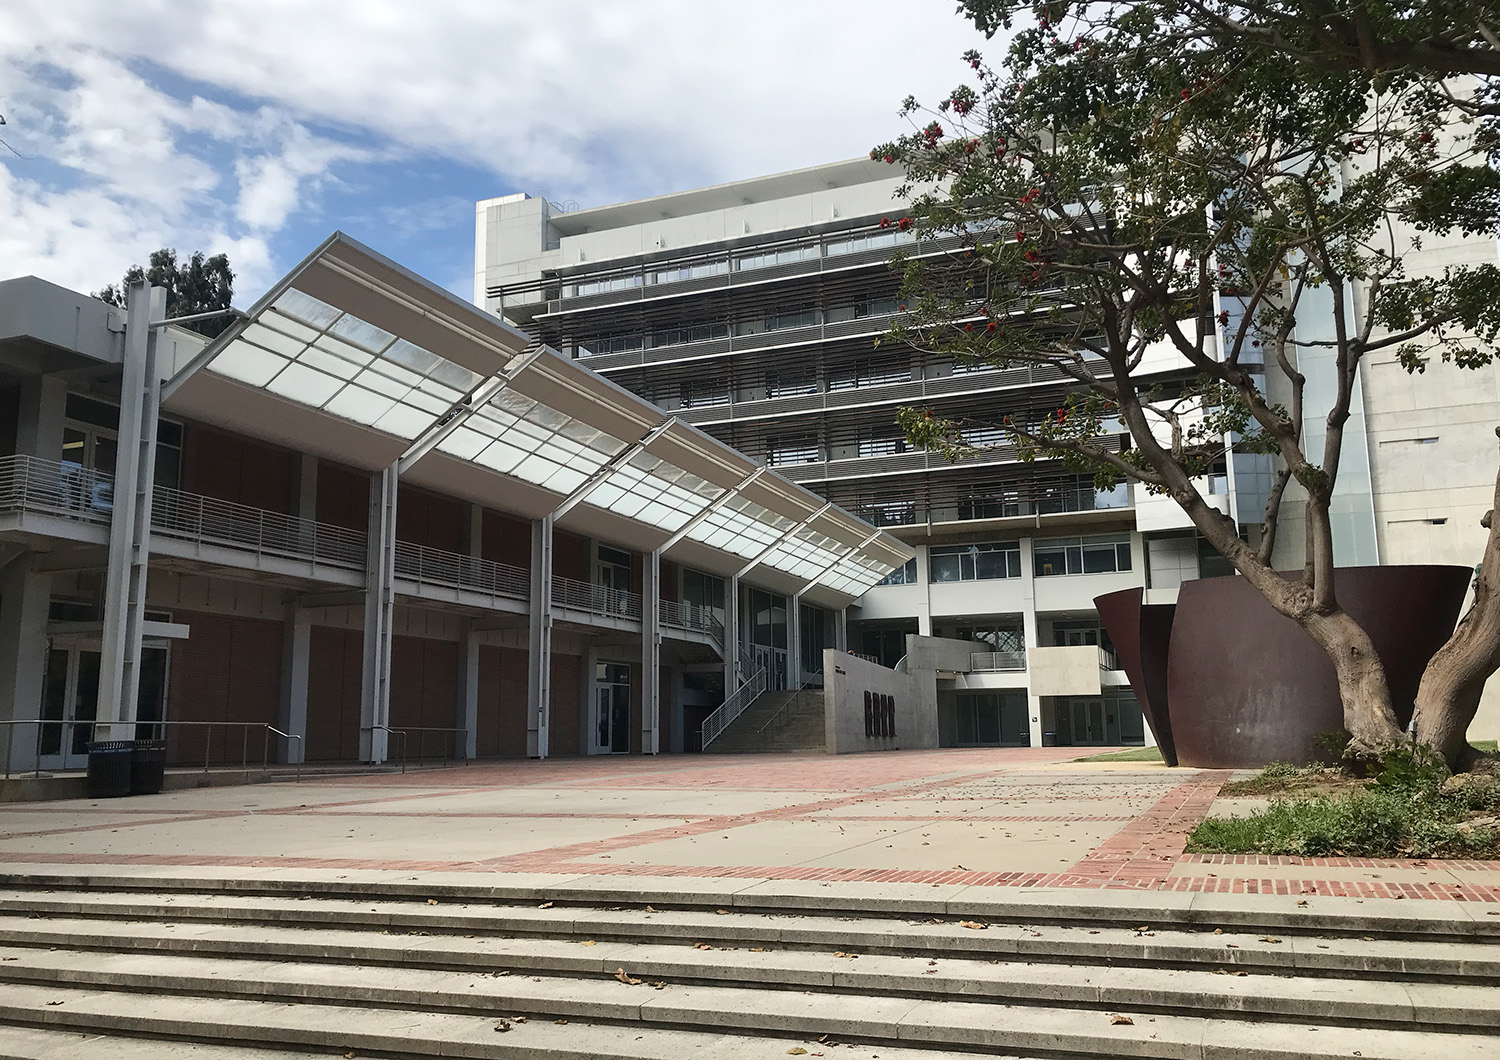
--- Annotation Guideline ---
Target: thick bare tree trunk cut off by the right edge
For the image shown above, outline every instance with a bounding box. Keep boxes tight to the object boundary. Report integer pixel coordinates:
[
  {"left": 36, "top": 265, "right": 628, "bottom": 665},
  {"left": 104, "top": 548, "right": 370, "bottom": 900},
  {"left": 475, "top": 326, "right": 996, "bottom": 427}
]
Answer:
[{"left": 1412, "top": 446, "right": 1500, "bottom": 769}]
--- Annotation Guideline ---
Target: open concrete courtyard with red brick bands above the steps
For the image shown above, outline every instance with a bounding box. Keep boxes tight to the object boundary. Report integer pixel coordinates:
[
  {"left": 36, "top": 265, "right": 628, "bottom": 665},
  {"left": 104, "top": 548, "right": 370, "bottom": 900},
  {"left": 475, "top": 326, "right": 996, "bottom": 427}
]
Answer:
[{"left": 0, "top": 748, "right": 1500, "bottom": 903}]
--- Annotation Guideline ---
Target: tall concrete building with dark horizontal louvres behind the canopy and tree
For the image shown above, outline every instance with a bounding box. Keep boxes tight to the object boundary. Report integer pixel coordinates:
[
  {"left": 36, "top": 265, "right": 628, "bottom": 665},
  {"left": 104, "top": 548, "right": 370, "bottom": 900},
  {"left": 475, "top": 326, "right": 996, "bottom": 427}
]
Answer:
[{"left": 474, "top": 159, "right": 1494, "bottom": 755}]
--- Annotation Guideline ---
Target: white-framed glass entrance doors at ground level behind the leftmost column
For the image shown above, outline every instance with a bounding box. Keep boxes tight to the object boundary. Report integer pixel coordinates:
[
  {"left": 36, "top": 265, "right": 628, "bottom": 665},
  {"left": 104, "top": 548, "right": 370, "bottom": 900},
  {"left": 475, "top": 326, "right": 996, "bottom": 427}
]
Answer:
[{"left": 38, "top": 637, "right": 170, "bottom": 769}]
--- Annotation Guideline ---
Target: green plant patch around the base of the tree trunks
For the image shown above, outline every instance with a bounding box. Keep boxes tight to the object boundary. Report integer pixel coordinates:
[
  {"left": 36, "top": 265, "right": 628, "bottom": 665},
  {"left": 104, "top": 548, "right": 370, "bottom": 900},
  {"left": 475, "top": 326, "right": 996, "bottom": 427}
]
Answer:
[{"left": 1187, "top": 750, "right": 1500, "bottom": 858}]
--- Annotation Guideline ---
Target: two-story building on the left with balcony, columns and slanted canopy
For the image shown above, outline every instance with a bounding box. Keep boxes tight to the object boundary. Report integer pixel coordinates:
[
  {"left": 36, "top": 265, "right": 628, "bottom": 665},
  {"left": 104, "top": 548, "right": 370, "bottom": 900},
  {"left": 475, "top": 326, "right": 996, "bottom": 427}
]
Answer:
[{"left": 0, "top": 235, "right": 912, "bottom": 771}]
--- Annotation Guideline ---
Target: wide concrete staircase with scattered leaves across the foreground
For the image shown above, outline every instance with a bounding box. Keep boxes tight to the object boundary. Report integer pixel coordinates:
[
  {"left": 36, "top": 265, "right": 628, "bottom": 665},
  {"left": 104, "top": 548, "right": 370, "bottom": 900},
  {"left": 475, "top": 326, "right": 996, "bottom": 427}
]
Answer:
[{"left": 0, "top": 876, "right": 1500, "bottom": 1060}]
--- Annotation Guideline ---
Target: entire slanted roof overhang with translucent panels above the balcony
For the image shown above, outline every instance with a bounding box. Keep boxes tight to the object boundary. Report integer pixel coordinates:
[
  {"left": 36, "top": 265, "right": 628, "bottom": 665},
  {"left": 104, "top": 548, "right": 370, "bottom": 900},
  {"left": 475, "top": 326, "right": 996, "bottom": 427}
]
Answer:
[{"left": 164, "top": 234, "right": 914, "bottom": 607}]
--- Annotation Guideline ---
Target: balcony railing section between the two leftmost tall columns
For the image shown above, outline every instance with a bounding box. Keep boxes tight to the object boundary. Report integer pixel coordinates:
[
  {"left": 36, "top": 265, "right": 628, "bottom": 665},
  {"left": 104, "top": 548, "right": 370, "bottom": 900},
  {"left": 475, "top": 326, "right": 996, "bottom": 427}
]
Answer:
[{"left": 152, "top": 486, "right": 366, "bottom": 570}]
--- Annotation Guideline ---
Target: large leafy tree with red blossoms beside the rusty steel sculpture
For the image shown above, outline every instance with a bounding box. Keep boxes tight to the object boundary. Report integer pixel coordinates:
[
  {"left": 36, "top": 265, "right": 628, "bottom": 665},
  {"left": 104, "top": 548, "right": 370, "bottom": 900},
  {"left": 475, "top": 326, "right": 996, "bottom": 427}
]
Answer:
[{"left": 872, "top": 0, "right": 1500, "bottom": 763}]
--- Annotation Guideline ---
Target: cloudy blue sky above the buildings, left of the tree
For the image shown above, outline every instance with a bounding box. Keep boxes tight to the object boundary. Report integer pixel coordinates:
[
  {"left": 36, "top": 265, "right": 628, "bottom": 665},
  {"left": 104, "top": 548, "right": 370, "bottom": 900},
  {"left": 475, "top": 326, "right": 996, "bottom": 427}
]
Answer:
[{"left": 0, "top": 0, "right": 984, "bottom": 306}]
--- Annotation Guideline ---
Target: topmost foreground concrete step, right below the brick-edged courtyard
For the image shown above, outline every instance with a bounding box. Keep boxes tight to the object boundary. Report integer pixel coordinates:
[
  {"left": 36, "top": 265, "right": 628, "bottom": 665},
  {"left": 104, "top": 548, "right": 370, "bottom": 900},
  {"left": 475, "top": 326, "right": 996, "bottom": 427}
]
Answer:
[{"left": 0, "top": 873, "right": 1500, "bottom": 957}]
